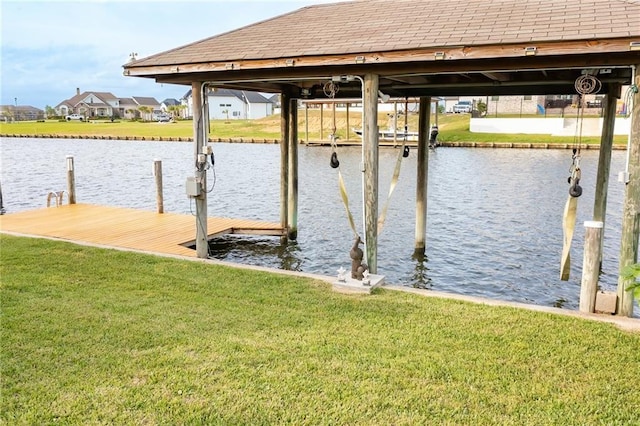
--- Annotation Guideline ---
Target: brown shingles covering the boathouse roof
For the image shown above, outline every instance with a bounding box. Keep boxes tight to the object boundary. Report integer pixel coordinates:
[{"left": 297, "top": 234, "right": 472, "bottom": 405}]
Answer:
[{"left": 128, "top": 0, "right": 640, "bottom": 66}]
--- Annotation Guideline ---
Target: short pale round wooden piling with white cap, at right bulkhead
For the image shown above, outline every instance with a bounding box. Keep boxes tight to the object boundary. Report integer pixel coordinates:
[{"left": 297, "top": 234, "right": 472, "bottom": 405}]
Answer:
[{"left": 580, "top": 221, "right": 604, "bottom": 313}]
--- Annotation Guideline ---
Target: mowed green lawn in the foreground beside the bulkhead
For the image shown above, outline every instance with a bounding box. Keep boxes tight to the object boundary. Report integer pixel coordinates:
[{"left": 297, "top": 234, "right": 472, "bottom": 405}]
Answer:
[{"left": 0, "top": 235, "right": 640, "bottom": 425}]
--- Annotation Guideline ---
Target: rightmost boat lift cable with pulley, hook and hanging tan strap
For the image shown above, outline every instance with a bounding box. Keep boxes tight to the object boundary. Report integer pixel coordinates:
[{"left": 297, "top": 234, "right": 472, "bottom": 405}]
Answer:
[{"left": 560, "top": 74, "right": 602, "bottom": 281}]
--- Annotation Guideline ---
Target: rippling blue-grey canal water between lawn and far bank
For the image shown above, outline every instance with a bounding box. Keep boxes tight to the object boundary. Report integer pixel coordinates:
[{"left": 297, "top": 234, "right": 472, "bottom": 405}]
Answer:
[{"left": 0, "top": 138, "right": 637, "bottom": 310}]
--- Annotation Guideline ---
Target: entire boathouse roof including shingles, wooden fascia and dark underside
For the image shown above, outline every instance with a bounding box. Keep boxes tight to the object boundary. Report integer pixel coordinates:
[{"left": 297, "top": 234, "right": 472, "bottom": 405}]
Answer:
[{"left": 124, "top": 0, "right": 640, "bottom": 97}]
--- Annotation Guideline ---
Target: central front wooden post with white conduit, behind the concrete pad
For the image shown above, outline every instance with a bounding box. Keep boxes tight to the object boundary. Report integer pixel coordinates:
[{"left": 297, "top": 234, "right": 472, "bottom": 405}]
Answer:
[{"left": 362, "top": 74, "right": 379, "bottom": 274}]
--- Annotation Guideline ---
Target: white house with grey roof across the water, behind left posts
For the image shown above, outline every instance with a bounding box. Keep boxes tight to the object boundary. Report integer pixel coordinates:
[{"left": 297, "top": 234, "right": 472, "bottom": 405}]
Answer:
[{"left": 183, "top": 88, "right": 274, "bottom": 120}]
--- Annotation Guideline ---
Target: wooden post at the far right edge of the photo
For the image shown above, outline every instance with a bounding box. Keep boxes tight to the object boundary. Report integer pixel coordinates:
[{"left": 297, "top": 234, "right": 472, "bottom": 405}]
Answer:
[{"left": 617, "top": 69, "right": 640, "bottom": 317}]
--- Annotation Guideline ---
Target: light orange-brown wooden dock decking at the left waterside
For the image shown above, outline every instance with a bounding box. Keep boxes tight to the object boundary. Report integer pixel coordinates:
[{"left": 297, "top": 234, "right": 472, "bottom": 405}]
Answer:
[{"left": 0, "top": 204, "right": 283, "bottom": 257}]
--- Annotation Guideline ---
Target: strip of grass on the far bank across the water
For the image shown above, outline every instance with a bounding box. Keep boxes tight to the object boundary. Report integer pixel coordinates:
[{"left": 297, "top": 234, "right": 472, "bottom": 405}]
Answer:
[{"left": 0, "top": 110, "right": 627, "bottom": 145}]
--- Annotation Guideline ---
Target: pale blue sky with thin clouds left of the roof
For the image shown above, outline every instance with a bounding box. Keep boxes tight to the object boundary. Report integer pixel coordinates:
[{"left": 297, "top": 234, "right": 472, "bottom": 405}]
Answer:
[{"left": 0, "top": 0, "right": 340, "bottom": 109}]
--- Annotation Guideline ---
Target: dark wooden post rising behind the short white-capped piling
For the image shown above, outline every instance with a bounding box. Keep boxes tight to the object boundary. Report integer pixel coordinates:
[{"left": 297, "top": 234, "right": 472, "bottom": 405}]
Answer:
[{"left": 593, "top": 85, "right": 620, "bottom": 268}]
